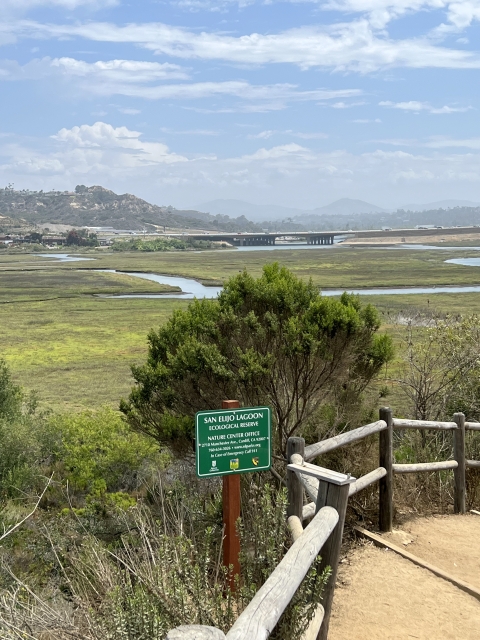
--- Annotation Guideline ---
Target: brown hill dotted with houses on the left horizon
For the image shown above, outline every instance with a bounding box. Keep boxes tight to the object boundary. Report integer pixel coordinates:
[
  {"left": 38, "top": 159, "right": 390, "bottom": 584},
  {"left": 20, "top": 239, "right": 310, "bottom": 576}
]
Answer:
[{"left": 0, "top": 185, "right": 260, "bottom": 231}]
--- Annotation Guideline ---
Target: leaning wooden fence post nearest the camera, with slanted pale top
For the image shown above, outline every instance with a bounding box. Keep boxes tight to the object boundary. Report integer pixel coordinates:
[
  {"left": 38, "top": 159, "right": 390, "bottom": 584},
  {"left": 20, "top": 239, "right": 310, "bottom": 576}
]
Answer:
[{"left": 316, "top": 476, "right": 351, "bottom": 640}]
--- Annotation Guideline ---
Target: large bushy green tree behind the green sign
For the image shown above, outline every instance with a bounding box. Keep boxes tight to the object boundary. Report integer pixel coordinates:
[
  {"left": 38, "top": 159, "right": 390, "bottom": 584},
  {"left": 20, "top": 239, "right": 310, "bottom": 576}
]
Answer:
[{"left": 121, "top": 263, "right": 393, "bottom": 452}]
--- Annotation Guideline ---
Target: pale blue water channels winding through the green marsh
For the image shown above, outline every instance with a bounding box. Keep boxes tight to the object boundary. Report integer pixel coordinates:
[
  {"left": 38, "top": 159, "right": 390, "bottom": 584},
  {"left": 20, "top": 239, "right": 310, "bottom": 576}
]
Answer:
[{"left": 36, "top": 250, "right": 480, "bottom": 300}]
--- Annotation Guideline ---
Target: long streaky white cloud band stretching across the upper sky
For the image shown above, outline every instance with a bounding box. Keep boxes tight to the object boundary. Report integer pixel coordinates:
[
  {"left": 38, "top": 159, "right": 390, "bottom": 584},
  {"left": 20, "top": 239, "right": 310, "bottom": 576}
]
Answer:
[{"left": 5, "top": 19, "right": 480, "bottom": 73}]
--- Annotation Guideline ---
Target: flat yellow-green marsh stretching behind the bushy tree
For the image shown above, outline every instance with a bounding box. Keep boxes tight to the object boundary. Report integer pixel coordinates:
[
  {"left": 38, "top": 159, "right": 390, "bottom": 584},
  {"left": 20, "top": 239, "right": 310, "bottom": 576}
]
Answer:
[{"left": 0, "top": 246, "right": 480, "bottom": 409}]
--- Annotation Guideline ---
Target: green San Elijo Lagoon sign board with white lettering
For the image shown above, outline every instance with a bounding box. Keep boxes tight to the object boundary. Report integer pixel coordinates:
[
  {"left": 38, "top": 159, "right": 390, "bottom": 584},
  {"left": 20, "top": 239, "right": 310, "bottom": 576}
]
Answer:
[{"left": 195, "top": 407, "right": 272, "bottom": 478}]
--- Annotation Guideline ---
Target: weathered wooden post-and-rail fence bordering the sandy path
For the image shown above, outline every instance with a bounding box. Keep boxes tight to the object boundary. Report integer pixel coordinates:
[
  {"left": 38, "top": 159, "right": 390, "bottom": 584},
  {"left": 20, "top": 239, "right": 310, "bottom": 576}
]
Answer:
[{"left": 166, "top": 408, "right": 480, "bottom": 640}]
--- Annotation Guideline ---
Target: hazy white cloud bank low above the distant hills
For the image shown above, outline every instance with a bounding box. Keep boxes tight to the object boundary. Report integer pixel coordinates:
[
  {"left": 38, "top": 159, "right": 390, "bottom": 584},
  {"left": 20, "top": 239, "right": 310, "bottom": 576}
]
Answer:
[{"left": 0, "top": 122, "right": 480, "bottom": 207}]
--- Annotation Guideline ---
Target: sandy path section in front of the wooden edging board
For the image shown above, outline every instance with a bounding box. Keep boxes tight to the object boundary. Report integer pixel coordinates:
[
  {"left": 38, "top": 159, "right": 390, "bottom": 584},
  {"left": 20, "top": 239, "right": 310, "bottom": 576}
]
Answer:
[{"left": 329, "top": 544, "right": 480, "bottom": 640}]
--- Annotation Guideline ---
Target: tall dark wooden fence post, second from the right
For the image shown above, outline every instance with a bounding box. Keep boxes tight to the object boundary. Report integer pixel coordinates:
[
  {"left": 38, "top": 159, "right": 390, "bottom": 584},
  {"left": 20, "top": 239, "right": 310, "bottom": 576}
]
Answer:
[{"left": 378, "top": 407, "right": 393, "bottom": 531}]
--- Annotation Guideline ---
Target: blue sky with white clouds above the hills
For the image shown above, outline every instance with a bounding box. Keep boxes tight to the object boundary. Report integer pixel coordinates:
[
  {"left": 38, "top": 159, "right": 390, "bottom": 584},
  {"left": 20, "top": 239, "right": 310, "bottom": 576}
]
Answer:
[{"left": 0, "top": 0, "right": 480, "bottom": 209}]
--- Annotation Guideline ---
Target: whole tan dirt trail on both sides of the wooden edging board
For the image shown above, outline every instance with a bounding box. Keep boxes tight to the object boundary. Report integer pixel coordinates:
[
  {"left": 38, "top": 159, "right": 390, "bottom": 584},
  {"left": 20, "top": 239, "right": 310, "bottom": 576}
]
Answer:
[{"left": 329, "top": 516, "right": 480, "bottom": 640}]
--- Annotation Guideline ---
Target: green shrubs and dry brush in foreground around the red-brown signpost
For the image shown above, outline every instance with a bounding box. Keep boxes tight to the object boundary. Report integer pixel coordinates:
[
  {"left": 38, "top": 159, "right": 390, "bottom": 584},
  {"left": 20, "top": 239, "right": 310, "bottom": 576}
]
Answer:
[{"left": 0, "top": 350, "right": 328, "bottom": 640}]
